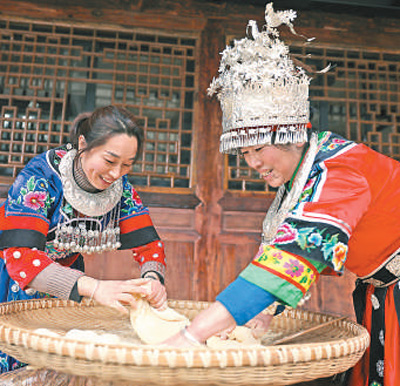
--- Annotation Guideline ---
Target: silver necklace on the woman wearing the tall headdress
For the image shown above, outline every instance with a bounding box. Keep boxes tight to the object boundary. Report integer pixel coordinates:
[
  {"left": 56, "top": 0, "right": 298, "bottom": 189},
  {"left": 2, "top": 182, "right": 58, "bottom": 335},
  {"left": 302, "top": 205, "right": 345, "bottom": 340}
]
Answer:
[{"left": 262, "top": 133, "right": 318, "bottom": 244}]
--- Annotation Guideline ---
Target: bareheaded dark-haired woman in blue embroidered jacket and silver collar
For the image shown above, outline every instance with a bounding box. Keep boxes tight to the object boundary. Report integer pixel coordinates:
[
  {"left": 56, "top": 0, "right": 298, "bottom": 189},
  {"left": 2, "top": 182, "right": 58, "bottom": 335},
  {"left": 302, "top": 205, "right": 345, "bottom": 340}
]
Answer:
[{"left": 0, "top": 106, "right": 166, "bottom": 372}]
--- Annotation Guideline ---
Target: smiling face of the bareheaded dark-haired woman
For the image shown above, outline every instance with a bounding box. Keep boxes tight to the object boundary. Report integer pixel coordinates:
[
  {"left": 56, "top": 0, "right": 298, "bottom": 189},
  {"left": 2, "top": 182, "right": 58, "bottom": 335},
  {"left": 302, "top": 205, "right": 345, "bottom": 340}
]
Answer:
[{"left": 79, "top": 134, "right": 138, "bottom": 190}]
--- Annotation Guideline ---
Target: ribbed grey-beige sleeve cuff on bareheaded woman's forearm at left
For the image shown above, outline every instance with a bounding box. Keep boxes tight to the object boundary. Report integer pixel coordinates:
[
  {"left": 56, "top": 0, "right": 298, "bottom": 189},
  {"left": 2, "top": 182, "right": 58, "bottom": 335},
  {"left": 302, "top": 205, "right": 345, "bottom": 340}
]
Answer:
[{"left": 29, "top": 263, "right": 84, "bottom": 300}]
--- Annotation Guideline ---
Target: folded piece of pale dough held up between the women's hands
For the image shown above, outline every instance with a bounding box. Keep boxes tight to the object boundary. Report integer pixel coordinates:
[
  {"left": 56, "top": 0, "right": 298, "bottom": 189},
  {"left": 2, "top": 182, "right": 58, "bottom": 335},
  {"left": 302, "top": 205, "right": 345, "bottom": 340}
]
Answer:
[{"left": 130, "top": 298, "right": 190, "bottom": 344}]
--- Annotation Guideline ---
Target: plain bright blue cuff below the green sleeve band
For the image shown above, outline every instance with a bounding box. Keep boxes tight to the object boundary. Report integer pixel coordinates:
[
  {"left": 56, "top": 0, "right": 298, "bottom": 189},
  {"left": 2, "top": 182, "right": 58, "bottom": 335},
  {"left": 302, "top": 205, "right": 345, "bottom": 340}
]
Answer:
[{"left": 216, "top": 277, "right": 276, "bottom": 326}]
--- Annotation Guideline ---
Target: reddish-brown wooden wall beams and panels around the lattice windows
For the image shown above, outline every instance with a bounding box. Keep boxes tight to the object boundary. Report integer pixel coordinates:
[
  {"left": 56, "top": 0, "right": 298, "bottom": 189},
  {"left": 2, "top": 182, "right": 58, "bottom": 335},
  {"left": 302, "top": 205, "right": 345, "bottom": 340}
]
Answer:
[{"left": 0, "top": 0, "right": 400, "bottom": 317}]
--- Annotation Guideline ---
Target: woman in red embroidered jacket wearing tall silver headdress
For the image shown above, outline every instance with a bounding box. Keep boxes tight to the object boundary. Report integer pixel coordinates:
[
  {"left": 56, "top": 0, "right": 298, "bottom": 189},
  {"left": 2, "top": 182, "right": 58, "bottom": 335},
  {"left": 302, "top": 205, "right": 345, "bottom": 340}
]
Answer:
[{"left": 165, "top": 3, "right": 400, "bottom": 386}]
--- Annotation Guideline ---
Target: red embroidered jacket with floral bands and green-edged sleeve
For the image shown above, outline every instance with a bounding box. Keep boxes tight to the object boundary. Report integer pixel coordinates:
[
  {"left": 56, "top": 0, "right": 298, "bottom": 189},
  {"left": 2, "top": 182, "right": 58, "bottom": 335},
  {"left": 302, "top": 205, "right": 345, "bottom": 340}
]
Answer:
[{"left": 240, "top": 132, "right": 400, "bottom": 307}]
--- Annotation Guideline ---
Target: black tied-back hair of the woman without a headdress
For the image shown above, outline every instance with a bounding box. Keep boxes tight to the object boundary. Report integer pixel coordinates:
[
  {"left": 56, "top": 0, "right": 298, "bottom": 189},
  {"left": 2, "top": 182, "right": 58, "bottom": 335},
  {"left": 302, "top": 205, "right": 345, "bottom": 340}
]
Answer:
[{"left": 69, "top": 105, "right": 144, "bottom": 162}]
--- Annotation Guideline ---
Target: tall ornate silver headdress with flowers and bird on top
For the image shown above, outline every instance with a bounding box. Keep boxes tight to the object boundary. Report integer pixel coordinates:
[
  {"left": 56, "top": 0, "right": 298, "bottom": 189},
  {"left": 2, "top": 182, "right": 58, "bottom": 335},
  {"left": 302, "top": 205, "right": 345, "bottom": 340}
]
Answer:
[{"left": 208, "top": 3, "right": 310, "bottom": 154}]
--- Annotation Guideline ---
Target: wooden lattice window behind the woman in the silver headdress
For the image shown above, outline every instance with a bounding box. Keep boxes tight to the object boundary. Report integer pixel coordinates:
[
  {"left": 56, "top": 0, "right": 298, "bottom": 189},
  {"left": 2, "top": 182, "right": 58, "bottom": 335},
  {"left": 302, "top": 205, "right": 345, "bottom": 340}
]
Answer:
[{"left": 225, "top": 45, "right": 400, "bottom": 191}]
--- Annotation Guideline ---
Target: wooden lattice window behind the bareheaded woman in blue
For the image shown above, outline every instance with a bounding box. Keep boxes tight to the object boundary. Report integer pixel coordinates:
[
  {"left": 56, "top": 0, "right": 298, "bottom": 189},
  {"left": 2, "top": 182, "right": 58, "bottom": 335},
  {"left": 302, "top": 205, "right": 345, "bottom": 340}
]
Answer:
[{"left": 0, "top": 20, "right": 198, "bottom": 188}]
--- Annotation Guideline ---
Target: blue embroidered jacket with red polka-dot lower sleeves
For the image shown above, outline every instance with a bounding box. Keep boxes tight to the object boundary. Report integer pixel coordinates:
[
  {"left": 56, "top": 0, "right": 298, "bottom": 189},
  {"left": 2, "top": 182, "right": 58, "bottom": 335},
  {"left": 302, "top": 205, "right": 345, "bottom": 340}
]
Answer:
[{"left": 0, "top": 147, "right": 165, "bottom": 289}]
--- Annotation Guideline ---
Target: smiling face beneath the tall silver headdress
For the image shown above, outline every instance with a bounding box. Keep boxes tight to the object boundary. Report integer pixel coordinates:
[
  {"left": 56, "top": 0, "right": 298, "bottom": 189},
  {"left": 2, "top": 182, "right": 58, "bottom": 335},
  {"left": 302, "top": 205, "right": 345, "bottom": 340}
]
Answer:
[{"left": 240, "top": 143, "right": 304, "bottom": 188}]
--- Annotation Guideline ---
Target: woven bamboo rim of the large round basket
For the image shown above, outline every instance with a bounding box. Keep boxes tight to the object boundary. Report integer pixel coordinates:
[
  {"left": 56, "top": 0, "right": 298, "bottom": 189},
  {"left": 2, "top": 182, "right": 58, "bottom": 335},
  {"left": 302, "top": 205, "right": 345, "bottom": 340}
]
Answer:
[{"left": 0, "top": 298, "right": 370, "bottom": 368}]
